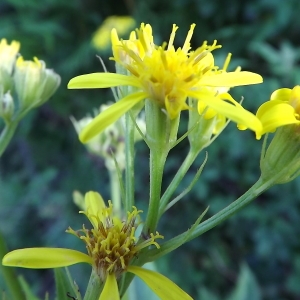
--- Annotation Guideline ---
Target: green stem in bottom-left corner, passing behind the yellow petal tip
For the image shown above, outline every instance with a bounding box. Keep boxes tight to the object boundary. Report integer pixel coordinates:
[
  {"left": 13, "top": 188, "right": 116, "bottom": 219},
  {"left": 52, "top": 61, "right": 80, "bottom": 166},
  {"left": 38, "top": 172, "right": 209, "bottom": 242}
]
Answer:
[{"left": 0, "top": 233, "right": 25, "bottom": 300}]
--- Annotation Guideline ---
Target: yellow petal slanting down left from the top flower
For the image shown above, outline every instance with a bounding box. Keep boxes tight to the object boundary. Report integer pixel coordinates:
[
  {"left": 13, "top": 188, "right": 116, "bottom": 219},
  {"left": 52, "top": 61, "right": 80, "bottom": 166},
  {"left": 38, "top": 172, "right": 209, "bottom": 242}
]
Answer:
[{"left": 79, "top": 92, "right": 148, "bottom": 143}]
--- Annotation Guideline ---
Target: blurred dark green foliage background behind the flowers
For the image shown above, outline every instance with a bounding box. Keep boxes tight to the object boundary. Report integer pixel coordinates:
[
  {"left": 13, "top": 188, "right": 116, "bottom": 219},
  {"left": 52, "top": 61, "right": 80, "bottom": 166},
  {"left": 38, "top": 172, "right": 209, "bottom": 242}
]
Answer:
[{"left": 0, "top": 0, "right": 300, "bottom": 300}]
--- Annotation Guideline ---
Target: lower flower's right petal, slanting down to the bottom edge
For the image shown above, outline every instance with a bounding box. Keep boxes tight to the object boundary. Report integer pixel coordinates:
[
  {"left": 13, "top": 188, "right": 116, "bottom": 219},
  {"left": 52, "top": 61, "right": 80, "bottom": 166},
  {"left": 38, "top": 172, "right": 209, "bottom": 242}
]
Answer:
[{"left": 127, "top": 266, "right": 193, "bottom": 300}]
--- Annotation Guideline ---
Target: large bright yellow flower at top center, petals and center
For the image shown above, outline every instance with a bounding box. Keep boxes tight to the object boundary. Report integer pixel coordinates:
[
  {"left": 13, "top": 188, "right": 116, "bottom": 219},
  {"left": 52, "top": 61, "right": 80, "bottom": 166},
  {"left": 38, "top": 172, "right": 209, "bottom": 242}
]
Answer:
[{"left": 68, "top": 24, "right": 262, "bottom": 142}]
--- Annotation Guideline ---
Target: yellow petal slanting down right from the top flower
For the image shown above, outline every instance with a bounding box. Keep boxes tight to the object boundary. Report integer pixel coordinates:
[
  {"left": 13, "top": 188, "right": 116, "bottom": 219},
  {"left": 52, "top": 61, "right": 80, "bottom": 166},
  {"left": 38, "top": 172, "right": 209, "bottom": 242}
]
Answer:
[{"left": 189, "top": 92, "right": 262, "bottom": 132}]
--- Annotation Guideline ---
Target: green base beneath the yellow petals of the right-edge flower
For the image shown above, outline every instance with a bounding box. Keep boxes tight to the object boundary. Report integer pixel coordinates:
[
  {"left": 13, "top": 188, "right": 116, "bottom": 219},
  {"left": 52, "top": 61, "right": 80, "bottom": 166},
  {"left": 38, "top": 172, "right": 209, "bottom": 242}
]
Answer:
[{"left": 260, "top": 124, "right": 300, "bottom": 184}]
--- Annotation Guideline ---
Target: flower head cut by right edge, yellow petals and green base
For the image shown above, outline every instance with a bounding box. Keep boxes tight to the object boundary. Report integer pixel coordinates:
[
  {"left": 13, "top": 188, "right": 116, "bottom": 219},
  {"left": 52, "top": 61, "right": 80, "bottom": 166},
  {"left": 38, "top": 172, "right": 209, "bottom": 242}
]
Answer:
[{"left": 257, "top": 86, "right": 300, "bottom": 184}]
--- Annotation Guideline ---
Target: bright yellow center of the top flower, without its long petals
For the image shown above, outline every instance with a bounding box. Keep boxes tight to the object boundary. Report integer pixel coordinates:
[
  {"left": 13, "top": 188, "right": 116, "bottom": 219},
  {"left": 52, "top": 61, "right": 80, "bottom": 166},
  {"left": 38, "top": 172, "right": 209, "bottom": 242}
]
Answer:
[{"left": 114, "top": 25, "right": 221, "bottom": 118}]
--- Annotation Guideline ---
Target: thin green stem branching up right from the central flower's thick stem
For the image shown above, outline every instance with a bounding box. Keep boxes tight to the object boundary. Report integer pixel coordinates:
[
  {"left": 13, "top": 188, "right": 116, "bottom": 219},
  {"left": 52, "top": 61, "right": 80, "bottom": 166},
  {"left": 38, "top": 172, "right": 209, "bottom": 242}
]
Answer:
[{"left": 159, "top": 148, "right": 199, "bottom": 218}]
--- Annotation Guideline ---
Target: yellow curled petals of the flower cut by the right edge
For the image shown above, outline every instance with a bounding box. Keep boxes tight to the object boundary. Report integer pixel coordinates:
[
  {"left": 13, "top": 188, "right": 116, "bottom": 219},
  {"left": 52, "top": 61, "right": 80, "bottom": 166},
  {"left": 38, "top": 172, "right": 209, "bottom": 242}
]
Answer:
[{"left": 256, "top": 85, "right": 300, "bottom": 135}]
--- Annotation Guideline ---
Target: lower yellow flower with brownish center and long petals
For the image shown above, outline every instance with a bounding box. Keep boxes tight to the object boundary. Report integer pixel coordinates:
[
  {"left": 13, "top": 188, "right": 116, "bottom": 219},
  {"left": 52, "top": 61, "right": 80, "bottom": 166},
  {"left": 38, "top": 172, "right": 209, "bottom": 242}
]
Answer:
[{"left": 2, "top": 192, "right": 192, "bottom": 300}]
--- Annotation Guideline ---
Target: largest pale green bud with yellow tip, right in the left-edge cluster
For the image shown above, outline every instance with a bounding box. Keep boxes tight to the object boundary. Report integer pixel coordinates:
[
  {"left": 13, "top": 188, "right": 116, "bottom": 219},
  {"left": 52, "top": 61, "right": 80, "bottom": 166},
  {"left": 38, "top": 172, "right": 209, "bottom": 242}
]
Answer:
[{"left": 14, "top": 56, "right": 60, "bottom": 109}]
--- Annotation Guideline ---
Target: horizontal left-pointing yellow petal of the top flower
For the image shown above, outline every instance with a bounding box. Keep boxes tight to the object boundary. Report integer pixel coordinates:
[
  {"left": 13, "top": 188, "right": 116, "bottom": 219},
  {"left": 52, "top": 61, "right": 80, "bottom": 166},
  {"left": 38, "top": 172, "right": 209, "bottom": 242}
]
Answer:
[{"left": 68, "top": 73, "right": 140, "bottom": 89}]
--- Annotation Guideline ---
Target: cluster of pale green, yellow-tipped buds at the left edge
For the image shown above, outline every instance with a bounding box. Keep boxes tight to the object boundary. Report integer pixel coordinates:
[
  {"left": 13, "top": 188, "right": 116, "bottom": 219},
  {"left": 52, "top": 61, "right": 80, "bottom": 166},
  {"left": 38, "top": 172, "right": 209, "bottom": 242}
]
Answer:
[{"left": 0, "top": 39, "right": 60, "bottom": 123}]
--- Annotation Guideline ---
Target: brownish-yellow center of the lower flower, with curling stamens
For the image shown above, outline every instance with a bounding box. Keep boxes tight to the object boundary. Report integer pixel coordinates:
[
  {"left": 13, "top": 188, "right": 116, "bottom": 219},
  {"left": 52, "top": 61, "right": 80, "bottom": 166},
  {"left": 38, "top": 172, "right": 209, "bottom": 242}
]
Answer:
[{"left": 67, "top": 201, "right": 163, "bottom": 281}]
